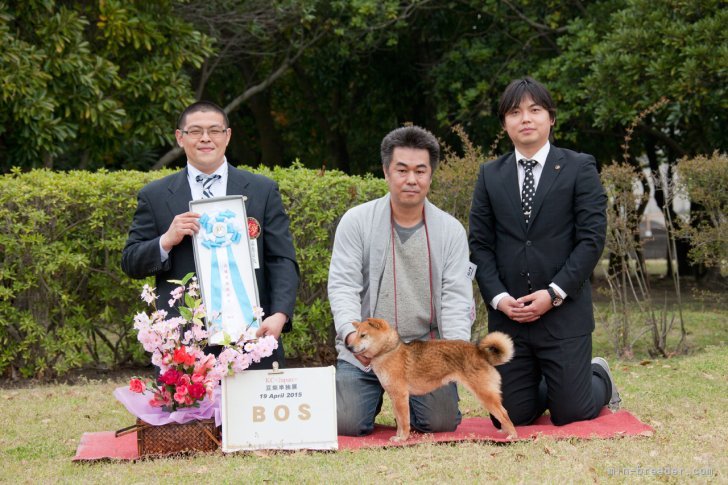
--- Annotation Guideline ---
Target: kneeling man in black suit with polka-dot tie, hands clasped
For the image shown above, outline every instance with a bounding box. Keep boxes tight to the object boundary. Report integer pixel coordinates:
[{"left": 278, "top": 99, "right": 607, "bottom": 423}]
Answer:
[{"left": 469, "top": 77, "right": 621, "bottom": 425}]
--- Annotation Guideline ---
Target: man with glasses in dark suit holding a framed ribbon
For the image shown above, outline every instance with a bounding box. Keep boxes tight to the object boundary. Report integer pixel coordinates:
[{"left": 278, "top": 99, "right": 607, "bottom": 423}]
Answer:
[{"left": 121, "top": 101, "right": 299, "bottom": 368}]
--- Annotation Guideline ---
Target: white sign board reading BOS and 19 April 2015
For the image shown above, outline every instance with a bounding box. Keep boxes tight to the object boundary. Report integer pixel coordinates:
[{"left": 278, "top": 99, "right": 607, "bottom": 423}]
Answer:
[{"left": 222, "top": 366, "right": 339, "bottom": 452}]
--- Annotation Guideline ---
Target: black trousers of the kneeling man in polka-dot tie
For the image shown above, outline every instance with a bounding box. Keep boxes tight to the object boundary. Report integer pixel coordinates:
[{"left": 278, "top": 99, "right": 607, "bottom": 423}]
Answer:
[{"left": 491, "top": 322, "right": 611, "bottom": 427}]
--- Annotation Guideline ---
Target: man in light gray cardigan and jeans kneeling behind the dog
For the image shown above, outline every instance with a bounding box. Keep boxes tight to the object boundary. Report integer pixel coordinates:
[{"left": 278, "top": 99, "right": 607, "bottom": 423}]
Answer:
[{"left": 328, "top": 126, "right": 473, "bottom": 436}]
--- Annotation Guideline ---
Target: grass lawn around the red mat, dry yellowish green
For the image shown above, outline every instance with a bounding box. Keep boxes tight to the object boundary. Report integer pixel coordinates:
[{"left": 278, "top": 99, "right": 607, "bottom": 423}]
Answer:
[{"left": 0, "top": 302, "right": 728, "bottom": 483}]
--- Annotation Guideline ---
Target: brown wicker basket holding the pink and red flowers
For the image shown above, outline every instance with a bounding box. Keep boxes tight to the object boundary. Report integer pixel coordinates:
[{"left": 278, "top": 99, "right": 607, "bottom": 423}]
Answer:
[{"left": 116, "top": 419, "right": 220, "bottom": 457}]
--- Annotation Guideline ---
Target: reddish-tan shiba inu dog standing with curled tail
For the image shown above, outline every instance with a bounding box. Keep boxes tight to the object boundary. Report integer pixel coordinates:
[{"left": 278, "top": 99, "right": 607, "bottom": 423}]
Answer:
[{"left": 350, "top": 318, "right": 518, "bottom": 441}]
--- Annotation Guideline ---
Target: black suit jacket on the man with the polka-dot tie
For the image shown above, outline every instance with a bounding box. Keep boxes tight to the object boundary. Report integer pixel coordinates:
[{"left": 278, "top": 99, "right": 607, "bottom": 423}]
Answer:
[{"left": 469, "top": 145, "right": 607, "bottom": 338}]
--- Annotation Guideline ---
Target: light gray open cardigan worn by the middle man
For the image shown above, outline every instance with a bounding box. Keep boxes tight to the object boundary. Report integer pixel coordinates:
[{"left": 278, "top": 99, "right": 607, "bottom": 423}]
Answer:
[{"left": 328, "top": 194, "right": 473, "bottom": 369}]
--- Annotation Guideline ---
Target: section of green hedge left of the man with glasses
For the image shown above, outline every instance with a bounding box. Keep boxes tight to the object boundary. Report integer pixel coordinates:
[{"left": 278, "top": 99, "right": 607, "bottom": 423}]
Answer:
[{"left": 0, "top": 170, "right": 161, "bottom": 376}]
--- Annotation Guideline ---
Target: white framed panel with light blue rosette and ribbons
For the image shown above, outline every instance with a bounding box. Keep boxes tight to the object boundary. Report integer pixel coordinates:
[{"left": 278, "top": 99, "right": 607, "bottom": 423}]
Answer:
[{"left": 190, "top": 195, "right": 262, "bottom": 344}]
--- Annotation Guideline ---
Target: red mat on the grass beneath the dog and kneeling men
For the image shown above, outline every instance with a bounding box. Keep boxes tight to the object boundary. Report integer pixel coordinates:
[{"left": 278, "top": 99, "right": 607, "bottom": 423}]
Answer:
[{"left": 73, "top": 408, "right": 653, "bottom": 461}]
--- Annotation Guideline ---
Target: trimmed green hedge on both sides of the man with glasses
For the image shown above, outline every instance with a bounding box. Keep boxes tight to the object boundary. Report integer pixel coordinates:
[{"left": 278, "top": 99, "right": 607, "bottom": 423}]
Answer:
[{"left": 0, "top": 164, "right": 386, "bottom": 377}]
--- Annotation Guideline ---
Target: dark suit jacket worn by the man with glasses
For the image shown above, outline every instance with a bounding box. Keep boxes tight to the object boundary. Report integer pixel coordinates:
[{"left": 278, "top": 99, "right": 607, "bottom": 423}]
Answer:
[{"left": 121, "top": 165, "right": 299, "bottom": 332}]
